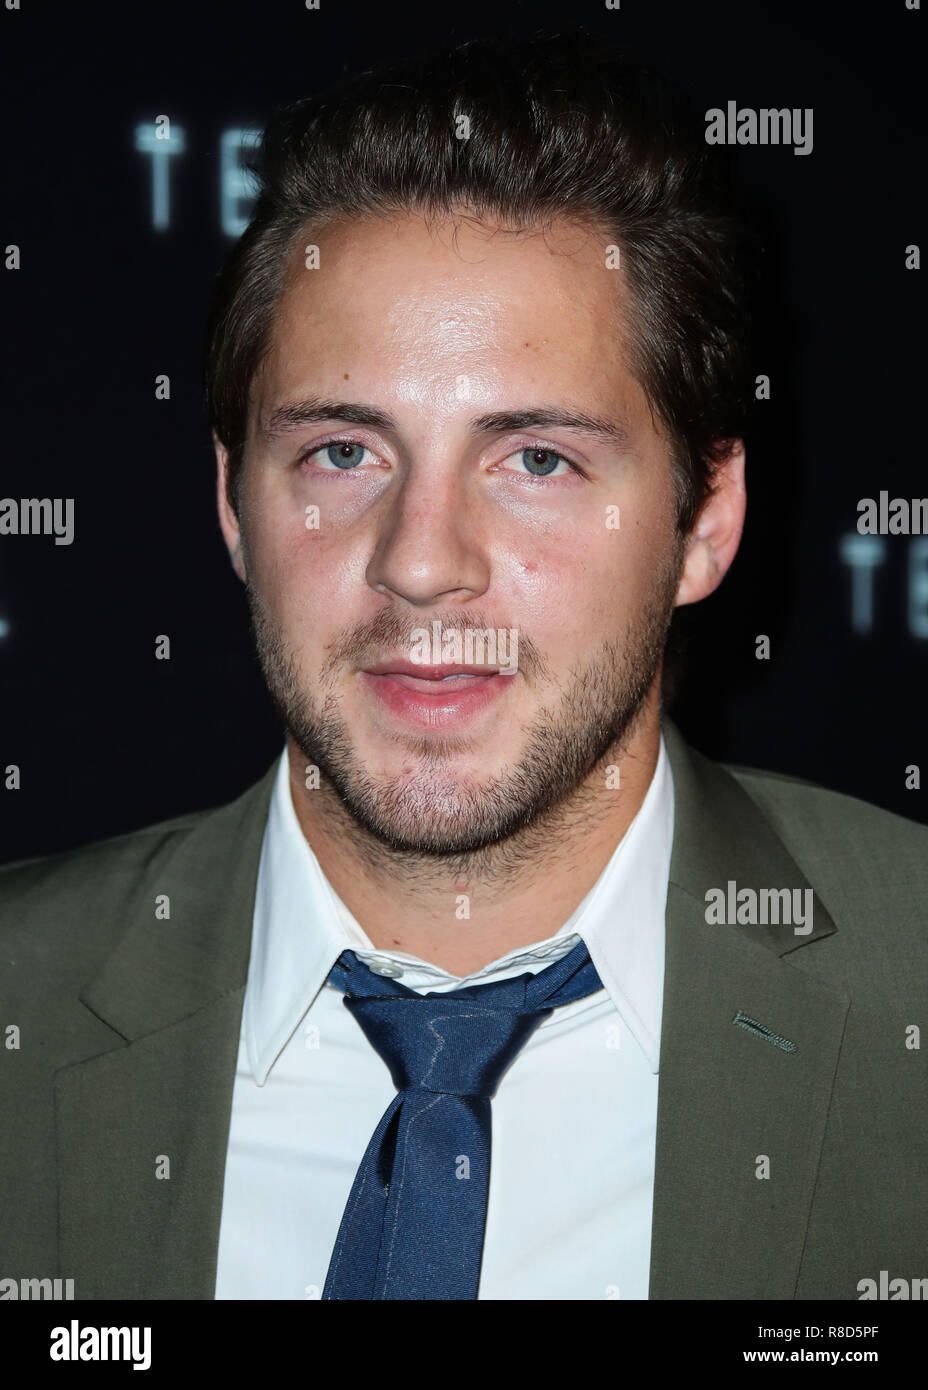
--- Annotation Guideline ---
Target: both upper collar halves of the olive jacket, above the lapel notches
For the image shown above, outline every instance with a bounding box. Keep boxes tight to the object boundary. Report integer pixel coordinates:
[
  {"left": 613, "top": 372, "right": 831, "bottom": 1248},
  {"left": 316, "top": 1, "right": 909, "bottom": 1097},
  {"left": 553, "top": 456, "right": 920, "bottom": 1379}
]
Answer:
[{"left": 81, "top": 717, "right": 835, "bottom": 1041}]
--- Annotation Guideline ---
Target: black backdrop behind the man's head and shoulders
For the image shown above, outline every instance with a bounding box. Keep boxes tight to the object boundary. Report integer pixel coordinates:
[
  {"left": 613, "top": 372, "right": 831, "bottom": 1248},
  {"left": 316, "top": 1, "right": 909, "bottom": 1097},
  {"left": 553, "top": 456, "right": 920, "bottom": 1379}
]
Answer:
[{"left": 0, "top": 0, "right": 928, "bottom": 860}]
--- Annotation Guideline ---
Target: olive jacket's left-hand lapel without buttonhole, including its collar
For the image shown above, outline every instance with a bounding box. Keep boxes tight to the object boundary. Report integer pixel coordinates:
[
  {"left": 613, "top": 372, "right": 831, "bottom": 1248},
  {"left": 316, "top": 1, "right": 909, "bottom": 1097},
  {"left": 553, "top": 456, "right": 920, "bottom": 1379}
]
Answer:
[{"left": 56, "top": 765, "right": 276, "bottom": 1298}]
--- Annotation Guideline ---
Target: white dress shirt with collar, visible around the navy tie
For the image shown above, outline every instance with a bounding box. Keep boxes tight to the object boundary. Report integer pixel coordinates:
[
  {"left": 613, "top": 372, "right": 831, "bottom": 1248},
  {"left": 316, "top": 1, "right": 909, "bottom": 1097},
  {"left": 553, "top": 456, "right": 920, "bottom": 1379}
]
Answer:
[{"left": 215, "top": 738, "right": 674, "bottom": 1300}]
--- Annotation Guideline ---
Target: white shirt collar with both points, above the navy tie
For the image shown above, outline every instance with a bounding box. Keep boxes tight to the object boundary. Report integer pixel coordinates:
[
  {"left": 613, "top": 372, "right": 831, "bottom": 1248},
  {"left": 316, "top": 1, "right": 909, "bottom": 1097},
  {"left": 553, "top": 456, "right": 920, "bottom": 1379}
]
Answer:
[{"left": 243, "top": 737, "right": 674, "bottom": 1086}]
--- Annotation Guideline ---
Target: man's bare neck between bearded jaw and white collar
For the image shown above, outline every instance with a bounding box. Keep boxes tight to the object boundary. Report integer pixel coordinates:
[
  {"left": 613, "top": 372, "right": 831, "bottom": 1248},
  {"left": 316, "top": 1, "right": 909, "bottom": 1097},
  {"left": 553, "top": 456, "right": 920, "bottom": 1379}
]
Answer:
[{"left": 288, "top": 691, "right": 660, "bottom": 976}]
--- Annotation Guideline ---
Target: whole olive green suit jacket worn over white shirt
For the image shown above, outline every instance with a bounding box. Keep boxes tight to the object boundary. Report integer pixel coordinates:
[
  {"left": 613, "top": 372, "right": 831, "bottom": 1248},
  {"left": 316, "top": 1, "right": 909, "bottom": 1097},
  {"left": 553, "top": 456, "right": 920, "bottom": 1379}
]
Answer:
[{"left": 0, "top": 720, "right": 928, "bottom": 1300}]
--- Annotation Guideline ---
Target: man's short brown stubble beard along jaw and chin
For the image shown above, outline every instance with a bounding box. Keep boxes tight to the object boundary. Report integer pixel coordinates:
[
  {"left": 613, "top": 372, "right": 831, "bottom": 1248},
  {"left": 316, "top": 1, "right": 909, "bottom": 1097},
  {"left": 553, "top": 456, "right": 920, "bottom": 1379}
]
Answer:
[{"left": 246, "top": 541, "right": 683, "bottom": 873}]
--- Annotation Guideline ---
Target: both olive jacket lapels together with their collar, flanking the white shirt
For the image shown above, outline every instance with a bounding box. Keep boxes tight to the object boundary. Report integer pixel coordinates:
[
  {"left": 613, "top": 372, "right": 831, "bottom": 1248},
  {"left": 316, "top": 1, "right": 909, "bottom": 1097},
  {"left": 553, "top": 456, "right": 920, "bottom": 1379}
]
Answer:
[{"left": 56, "top": 719, "right": 847, "bottom": 1298}]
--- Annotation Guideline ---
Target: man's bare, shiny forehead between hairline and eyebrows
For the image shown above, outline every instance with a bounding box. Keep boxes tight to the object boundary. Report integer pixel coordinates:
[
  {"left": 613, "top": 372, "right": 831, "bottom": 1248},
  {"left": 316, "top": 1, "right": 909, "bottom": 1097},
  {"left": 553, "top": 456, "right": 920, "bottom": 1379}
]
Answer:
[{"left": 251, "top": 208, "right": 635, "bottom": 431}]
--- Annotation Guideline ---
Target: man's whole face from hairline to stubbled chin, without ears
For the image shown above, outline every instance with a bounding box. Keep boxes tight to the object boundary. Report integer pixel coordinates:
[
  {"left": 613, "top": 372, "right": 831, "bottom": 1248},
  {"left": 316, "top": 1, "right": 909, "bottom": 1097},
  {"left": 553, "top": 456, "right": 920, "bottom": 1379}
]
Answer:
[{"left": 224, "top": 215, "right": 682, "bottom": 853}]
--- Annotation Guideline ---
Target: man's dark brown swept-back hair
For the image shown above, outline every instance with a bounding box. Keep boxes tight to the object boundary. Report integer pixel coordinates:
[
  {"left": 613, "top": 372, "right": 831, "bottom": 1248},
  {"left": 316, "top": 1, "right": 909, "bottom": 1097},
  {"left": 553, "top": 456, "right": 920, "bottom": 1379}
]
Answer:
[{"left": 204, "top": 29, "right": 750, "bottom": 534}]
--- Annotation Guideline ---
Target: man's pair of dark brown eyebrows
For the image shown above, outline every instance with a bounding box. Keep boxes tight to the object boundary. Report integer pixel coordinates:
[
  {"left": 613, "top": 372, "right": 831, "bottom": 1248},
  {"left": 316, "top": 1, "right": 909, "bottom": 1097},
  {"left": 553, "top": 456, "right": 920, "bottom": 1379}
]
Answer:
[{"left": 260, "top": 398, "right": 631, "bottom": 446}]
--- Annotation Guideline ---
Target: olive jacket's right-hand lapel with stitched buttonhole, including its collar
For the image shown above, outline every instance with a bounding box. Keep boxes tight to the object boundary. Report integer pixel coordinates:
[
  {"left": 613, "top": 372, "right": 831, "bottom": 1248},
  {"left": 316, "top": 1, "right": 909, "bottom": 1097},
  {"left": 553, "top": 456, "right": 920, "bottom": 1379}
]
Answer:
[{"left": 649, "top": 720, "right": 849, "bottom": 1298}]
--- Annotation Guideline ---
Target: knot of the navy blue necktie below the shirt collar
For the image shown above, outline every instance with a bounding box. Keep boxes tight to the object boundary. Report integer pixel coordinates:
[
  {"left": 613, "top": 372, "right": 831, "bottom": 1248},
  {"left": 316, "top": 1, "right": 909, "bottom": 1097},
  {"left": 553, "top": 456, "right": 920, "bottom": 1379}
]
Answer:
[{"left": 345, "top": 994, "right": 553, "bottom": 1099}]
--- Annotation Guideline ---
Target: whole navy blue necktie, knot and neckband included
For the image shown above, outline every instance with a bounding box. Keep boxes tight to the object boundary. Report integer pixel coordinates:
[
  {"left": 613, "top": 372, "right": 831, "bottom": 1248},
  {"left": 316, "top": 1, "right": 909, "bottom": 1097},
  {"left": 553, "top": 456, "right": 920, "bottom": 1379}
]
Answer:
[{"left": 322, "top": 941, "right": 603, "bottom": 1300}]
